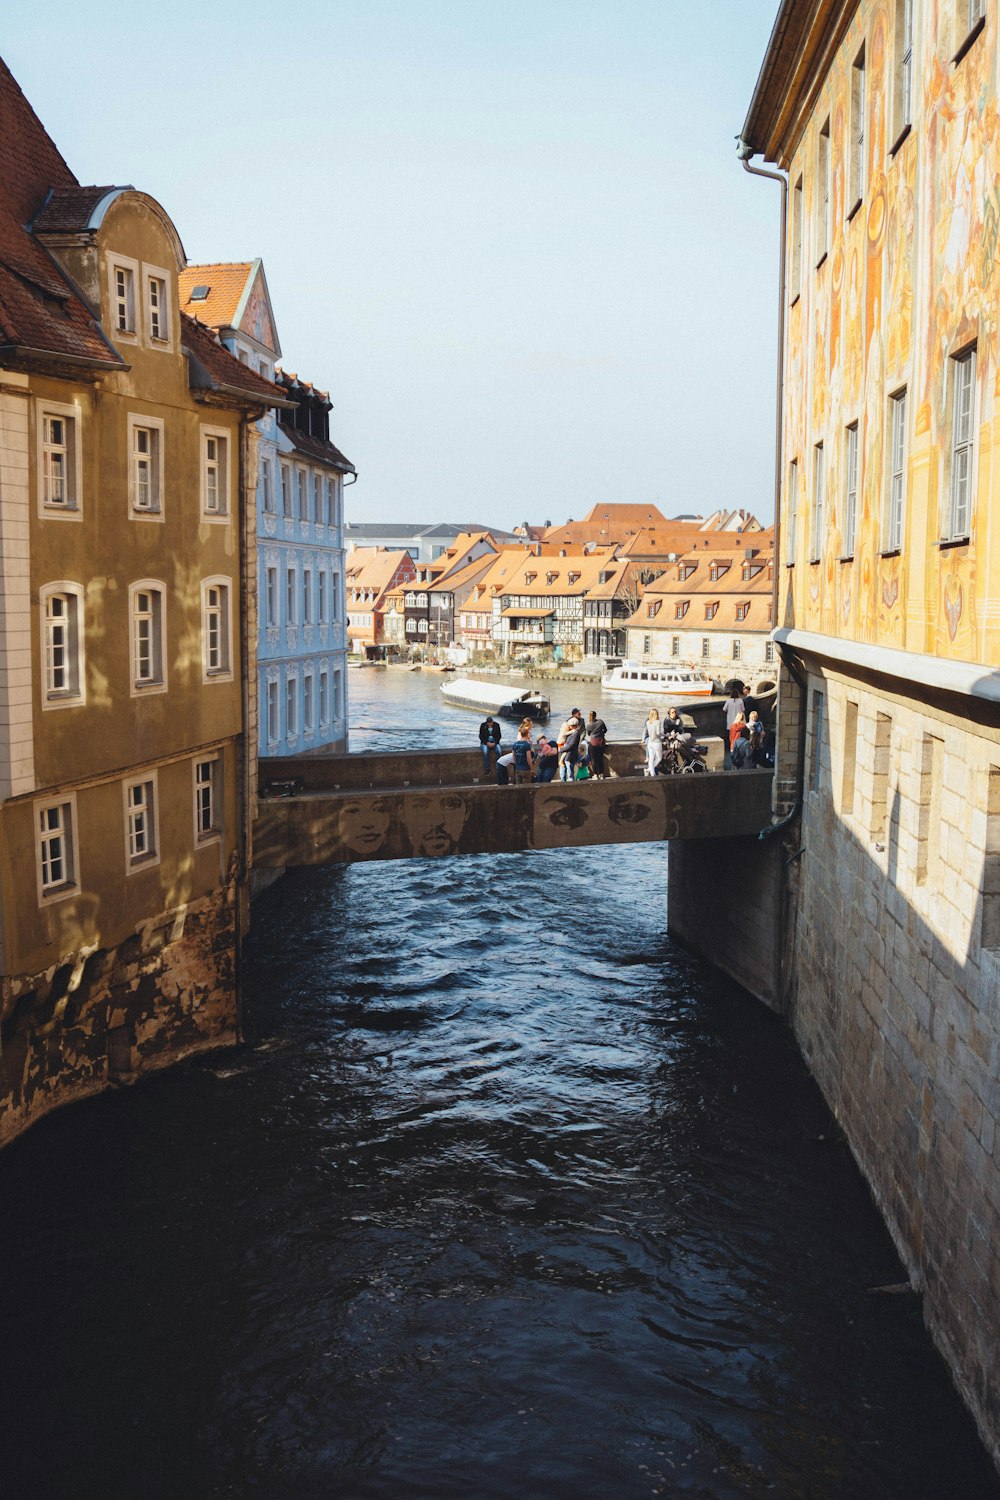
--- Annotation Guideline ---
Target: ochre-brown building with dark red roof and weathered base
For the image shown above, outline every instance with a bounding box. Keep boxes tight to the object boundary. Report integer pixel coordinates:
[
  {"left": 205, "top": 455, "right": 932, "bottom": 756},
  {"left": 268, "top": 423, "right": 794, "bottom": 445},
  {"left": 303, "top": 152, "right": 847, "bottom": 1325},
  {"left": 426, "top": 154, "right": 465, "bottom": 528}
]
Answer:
[{"left": 0, "top": 52, "right": 282, "bottom": 1142}]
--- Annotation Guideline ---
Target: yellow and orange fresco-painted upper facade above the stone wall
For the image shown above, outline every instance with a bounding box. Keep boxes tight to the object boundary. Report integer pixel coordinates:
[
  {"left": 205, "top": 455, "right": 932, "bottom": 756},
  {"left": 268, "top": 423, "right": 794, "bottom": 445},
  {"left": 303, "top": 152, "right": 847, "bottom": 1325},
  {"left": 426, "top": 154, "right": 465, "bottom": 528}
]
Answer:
[{"left": 780, "top": 0, "right": 1000, "bottom": 666}]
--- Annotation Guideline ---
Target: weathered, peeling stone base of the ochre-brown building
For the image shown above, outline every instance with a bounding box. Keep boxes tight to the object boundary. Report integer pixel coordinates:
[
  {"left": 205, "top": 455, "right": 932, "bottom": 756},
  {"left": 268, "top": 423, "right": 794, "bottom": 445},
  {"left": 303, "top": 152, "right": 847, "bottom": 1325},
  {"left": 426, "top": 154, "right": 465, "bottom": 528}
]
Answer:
[{"left": 0, "top": 887, "right": 237, "bottom": 1146}]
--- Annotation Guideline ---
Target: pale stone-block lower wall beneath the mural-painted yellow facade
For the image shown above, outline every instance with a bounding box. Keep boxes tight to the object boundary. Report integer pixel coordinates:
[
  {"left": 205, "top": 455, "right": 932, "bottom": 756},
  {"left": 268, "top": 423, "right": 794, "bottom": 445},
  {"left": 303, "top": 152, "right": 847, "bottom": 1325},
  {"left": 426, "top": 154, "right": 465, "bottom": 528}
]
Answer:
[{"left": 787, "top": 665, "right": 1000, "bottom": 1460}]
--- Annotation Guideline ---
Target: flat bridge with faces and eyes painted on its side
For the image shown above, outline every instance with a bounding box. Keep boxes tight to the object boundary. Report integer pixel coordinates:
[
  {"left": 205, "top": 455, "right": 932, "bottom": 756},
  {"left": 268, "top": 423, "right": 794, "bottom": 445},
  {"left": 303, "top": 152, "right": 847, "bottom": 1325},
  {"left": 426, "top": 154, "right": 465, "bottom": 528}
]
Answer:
[{"left": 253, "top": 746, "right": 774, "bottom": 869}]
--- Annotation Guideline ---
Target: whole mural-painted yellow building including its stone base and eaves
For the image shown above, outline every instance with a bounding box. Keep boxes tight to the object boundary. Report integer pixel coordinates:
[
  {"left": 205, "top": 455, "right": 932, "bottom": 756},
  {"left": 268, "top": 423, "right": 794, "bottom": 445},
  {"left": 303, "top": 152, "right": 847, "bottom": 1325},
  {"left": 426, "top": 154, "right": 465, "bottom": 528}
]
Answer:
[{"left": 741, "top": 0, "right": 1000, "bottom": 1457}]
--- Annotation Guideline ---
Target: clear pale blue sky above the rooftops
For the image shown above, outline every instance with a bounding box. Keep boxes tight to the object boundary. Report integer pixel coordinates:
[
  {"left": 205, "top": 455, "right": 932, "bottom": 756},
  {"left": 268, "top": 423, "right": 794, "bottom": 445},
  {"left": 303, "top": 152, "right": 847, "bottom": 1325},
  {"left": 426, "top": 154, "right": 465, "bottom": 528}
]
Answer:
[{"left": 0, "top": 0, "right": 780, "bottom": 528}]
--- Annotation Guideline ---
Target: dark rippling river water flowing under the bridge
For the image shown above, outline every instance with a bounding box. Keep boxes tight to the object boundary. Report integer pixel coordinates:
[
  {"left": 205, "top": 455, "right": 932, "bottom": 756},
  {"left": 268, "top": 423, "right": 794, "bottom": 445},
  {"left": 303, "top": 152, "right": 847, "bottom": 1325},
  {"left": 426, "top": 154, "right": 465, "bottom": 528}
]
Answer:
[{"left": 0, "top": 672, "right": 1000, "bottom": 1500}]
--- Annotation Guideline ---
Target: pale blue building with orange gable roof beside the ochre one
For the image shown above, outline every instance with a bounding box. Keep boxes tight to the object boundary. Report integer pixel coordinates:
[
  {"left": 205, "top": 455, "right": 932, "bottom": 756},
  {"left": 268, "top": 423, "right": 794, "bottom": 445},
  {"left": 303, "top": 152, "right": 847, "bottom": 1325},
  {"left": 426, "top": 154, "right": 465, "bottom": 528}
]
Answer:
[{"left": 180, "top": 260, "right": 355, "bottom": 756}]
